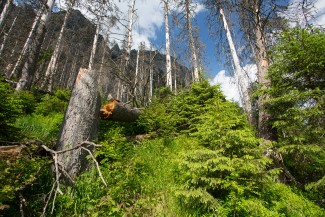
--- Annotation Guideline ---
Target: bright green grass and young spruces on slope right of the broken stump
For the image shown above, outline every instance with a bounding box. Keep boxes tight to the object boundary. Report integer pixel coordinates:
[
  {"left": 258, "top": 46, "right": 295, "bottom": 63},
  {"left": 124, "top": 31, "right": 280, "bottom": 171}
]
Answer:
[{"left": 54, "top": 81, "right": 324, "bottom": 217}]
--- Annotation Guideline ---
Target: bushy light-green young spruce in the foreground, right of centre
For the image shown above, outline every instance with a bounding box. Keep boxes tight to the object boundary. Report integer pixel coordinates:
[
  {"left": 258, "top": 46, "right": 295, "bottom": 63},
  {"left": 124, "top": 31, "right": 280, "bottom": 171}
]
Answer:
[{"left": 171, "top": 82, "right": 277, "bottom": 216}]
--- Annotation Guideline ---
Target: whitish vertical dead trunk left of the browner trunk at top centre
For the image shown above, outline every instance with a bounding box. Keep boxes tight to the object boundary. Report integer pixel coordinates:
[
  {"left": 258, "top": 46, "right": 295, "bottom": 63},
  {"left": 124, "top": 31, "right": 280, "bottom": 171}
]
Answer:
[{"left": 164, "top": 0, "right": 173, "bottom": 90}]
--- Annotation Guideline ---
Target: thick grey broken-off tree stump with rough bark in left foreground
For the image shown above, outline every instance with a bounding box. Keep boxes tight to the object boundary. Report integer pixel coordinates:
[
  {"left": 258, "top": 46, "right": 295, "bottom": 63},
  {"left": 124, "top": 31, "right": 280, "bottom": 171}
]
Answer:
[{"left": 57, "top": 68, "right": 100, "bottom": 178}]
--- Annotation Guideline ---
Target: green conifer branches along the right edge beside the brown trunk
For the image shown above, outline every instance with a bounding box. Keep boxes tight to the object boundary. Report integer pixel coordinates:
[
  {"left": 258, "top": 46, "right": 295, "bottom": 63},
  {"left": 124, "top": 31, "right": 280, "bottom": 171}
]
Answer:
[{"left": 264, "top": 28, "right": 325, "bottom": 201}]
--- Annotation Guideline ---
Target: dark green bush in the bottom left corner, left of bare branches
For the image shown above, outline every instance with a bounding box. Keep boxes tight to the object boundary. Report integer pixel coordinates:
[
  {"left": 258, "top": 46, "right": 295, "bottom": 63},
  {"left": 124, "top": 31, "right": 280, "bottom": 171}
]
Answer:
[{"left": 0, "top": 154, "right": 52, "bottom": 216}]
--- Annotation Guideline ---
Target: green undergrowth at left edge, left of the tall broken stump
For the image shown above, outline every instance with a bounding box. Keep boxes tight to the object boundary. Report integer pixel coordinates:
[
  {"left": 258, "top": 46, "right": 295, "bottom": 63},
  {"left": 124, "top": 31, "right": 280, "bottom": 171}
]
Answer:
[{"left": 0, "top": 82, "right": 70, "bottom": 216}]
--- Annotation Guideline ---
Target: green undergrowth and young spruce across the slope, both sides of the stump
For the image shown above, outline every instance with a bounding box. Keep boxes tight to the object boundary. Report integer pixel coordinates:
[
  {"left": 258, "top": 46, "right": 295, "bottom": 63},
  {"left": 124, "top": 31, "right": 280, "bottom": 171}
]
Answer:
[{"left": 0, "top": 77, "right": 325, "bottom": 217}]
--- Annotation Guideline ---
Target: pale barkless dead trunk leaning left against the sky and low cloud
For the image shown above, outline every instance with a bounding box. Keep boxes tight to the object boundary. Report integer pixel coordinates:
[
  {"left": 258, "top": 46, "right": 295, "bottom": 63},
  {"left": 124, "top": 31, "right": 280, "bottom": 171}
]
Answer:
[{"left": 219, "top": 5, "right": 253, "bottom": 123}]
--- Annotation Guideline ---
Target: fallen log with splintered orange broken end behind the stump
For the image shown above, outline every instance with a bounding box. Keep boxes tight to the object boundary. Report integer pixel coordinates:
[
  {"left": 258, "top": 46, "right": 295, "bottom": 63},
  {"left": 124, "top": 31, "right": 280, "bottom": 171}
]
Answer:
[{"left": 100, "top": 98, "right": 141, "bottom": 122}]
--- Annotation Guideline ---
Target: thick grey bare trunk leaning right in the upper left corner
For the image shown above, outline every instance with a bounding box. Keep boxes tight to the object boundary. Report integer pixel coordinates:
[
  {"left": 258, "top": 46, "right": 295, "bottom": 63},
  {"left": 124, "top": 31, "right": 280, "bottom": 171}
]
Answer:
[{"left": 16, "top": 0, "right": 55, "bottom": 91}]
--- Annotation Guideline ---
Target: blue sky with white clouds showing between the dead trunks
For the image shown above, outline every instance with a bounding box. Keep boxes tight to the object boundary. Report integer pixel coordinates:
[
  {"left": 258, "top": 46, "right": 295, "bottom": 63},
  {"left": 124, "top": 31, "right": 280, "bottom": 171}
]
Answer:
[{"left": 61, "top": 0, "right": 325, "bottom": 101}]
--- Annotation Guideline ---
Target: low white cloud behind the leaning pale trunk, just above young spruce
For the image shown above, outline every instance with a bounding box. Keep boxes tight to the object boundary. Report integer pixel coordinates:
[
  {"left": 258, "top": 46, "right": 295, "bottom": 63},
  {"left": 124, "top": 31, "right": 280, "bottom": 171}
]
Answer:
[{"left": 210, "top": 64, "right": 257, "bottom": 105}]
